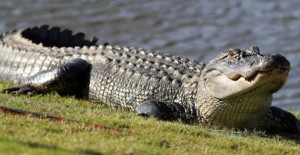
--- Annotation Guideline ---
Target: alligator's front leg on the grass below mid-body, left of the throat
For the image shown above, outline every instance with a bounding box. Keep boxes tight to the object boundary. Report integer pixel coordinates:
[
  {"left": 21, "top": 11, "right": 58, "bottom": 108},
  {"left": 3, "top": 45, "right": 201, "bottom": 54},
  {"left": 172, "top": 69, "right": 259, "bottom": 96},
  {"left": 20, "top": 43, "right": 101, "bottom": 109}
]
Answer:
[{"left": 136, "top": 100, "right": 193, "bottom": 123}]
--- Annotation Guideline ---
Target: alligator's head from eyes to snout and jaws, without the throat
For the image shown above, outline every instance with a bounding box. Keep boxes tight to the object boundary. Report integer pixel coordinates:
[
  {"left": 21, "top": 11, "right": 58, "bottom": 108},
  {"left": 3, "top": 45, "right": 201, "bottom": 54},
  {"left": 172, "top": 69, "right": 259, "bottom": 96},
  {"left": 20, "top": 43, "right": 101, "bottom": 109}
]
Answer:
[{"left": 204, "top": 46, "right": 290, "bottom": 99}]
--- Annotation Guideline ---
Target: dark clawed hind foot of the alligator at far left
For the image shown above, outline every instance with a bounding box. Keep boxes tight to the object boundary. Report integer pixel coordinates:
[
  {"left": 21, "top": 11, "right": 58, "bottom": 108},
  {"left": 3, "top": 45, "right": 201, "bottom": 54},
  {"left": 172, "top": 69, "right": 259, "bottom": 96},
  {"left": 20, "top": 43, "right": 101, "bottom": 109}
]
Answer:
[{"left": 2, "top": 85, "right": 36, "bottom": 96}]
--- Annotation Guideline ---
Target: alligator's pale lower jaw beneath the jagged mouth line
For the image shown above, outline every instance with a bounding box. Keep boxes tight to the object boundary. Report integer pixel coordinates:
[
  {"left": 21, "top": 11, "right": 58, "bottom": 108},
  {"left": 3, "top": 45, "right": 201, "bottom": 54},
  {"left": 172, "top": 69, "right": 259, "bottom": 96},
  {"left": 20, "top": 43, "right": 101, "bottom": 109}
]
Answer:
[{"left": 204, "top": 68, "right": 289, "bottom": 99}]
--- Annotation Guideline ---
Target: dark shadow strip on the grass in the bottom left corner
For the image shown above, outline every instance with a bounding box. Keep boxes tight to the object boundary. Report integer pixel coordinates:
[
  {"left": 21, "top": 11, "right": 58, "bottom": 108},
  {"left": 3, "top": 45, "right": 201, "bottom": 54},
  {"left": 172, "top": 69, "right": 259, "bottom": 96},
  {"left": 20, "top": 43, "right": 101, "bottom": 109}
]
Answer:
[{"left": 0, "top": 139, "right": 102, "bottom": 155}]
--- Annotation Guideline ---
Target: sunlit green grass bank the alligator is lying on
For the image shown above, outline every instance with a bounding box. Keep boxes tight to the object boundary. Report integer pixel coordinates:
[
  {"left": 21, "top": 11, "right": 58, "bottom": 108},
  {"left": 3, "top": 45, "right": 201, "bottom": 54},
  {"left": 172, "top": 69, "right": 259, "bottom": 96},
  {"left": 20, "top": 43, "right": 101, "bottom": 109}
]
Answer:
[{"left": 0, "top": 83, "right": 300, "bottom": 155}]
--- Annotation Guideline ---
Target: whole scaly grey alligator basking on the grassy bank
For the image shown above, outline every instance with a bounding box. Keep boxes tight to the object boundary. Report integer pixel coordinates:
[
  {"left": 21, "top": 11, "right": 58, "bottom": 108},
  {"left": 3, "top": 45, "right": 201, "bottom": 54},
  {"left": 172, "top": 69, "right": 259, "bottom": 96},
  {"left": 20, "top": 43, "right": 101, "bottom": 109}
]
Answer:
[{"left": 0, "top": 25, "right": 300, "bottom": 133}]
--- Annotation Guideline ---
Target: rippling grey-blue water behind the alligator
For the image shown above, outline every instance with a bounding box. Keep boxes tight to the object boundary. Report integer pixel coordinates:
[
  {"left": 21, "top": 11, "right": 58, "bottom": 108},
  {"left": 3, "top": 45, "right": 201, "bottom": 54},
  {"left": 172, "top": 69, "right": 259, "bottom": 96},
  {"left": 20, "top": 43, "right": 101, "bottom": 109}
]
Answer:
[{"left": 0, "top": 0, "right": 300, "bottom": 111}]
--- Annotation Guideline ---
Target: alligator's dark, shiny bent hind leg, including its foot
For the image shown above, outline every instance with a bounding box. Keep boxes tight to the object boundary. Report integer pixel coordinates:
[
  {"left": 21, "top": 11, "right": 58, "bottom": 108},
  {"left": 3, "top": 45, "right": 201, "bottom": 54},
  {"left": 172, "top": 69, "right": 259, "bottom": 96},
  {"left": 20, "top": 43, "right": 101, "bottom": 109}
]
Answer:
[{"left": 2, "top": 58, "right": 91, "bottom": 98}]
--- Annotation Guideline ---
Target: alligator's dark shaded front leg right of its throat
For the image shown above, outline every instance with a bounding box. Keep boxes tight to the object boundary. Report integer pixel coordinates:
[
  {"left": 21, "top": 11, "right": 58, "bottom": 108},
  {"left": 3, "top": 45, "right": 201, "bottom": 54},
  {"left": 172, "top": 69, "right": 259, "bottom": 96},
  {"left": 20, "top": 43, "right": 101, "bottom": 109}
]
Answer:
[{"left": 263, "top": 106, "right": 300, "bottom": 133}]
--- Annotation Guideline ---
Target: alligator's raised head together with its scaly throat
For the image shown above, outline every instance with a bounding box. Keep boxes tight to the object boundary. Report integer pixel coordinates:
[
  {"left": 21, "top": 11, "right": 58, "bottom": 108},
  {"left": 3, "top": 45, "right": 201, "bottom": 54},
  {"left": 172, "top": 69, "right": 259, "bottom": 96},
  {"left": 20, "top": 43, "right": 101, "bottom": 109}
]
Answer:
[{"left": 197, "top": 46, "right": 290, "bottom": 128}]
